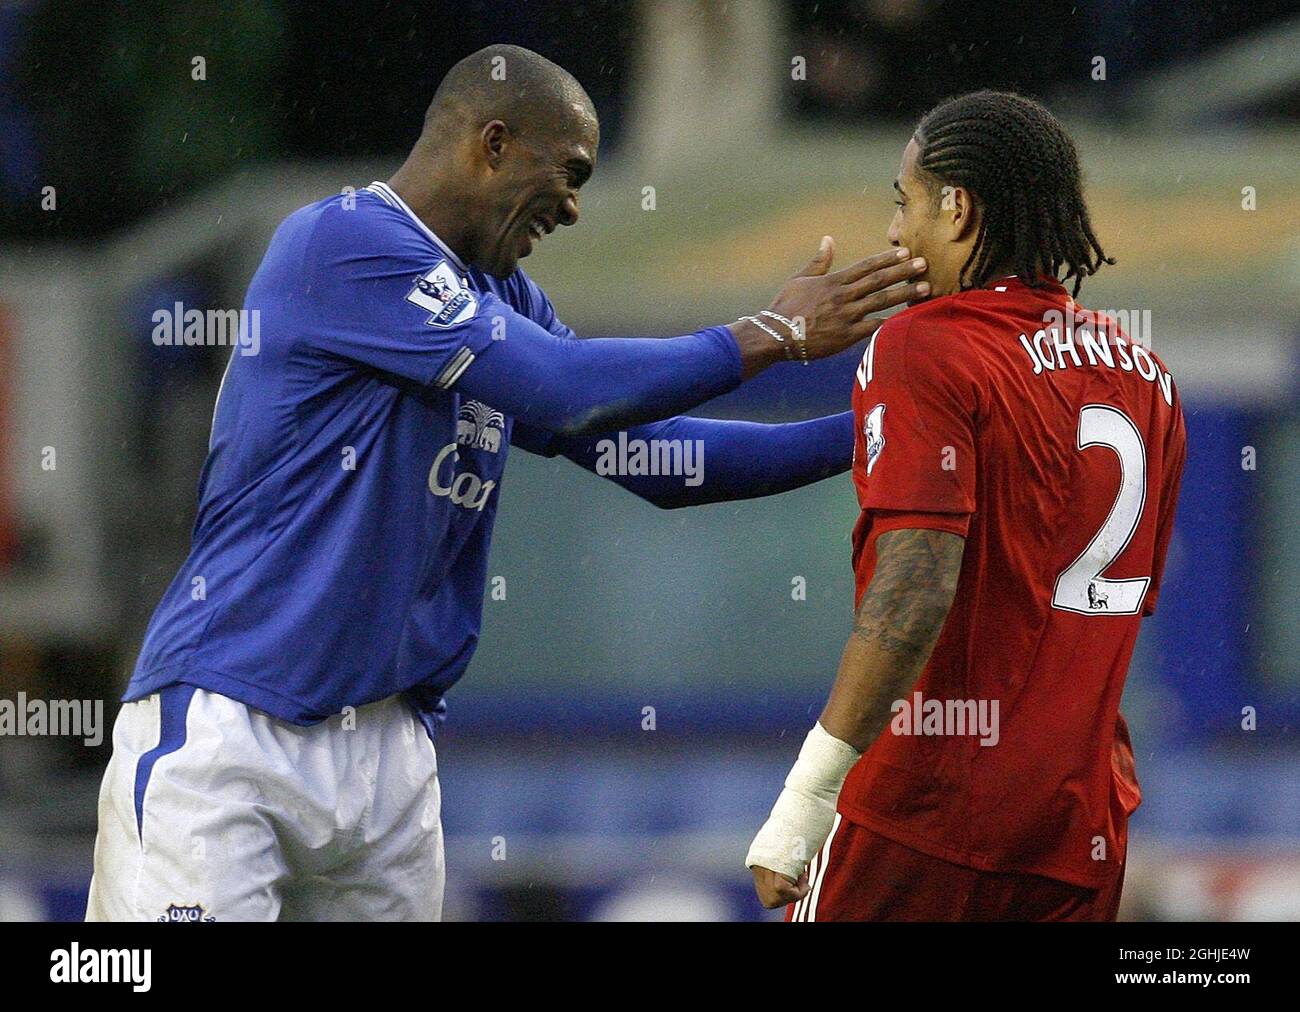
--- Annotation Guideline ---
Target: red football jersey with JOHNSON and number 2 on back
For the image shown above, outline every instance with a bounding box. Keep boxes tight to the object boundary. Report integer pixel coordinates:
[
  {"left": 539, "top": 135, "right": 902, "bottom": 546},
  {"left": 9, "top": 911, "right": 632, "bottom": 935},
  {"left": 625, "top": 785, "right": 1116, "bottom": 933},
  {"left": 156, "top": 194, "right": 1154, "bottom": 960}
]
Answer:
[{"left": 840, "top": 277, "right": 1186, "bottom": 887}]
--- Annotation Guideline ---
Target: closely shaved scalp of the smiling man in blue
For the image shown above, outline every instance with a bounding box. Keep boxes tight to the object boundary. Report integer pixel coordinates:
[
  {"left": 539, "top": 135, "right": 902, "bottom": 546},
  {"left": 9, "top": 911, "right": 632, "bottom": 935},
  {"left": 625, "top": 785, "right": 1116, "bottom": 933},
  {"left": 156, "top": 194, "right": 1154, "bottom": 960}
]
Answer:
[{"left": 424, "top": 46, "right": 595, "bottom": 138}]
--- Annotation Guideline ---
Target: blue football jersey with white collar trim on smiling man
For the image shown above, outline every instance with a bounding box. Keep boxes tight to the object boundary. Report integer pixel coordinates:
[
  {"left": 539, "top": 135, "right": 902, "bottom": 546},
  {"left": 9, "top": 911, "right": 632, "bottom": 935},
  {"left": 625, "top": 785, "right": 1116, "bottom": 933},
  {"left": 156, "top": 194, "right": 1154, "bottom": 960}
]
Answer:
[{"left": 125, "top": 182, "right": 572, "bottom": 730}]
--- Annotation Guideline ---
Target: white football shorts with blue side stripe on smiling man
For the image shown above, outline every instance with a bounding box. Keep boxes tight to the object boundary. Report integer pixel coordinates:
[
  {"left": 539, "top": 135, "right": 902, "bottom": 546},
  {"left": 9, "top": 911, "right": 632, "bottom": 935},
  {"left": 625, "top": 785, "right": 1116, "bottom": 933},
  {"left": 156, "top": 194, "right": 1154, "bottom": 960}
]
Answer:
[{"left": 86, "top": 686, "right": 446, "bottom": 922}]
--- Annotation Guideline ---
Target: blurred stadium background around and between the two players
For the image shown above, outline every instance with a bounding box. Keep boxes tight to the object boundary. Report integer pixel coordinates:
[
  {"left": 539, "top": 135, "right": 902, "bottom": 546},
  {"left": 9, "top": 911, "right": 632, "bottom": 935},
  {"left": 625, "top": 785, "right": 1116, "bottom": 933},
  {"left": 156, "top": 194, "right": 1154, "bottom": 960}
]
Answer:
[{"left": 0, "top": 0, "right": 1300, "bottom": 918}]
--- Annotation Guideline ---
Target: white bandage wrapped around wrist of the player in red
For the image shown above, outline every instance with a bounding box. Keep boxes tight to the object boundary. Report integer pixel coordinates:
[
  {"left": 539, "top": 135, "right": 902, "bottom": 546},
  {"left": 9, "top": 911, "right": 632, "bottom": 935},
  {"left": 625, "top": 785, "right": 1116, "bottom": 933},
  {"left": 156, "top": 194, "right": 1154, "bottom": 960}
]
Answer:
[{"left": 745, "top": 723, "right": 862, "bottom": 881}]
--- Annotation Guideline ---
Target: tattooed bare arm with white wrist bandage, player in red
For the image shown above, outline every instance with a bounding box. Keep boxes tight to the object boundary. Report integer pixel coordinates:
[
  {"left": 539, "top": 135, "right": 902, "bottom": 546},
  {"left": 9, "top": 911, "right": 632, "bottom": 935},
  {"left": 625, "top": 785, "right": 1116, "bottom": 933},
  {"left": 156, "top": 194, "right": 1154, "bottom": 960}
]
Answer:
[{"left": 745, "top": 529, "right": 966, "bottom": 907}]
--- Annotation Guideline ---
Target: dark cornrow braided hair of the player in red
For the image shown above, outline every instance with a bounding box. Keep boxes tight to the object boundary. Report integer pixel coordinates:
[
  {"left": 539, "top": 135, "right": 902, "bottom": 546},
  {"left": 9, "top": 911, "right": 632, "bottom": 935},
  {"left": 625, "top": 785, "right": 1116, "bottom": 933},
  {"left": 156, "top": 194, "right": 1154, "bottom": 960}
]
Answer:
[{"left": 915, "top": 91, "right": 1115, "bottom": 295}]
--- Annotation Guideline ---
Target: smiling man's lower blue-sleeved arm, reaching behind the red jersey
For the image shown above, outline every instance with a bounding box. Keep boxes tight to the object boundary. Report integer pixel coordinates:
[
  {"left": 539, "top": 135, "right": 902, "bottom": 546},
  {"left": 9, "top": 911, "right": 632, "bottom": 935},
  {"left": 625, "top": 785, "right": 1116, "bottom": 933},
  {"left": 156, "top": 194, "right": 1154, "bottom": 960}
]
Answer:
[{"left": 512, "top": 411, "right": 853, "bottom": 510}]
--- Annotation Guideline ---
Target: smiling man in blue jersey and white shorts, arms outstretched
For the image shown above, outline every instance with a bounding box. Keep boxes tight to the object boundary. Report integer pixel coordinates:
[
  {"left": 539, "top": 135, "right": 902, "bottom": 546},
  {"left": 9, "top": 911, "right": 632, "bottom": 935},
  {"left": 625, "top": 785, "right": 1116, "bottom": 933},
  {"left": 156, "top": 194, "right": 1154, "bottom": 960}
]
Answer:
[{"left": 87, "top": 46, "right": 926, "bottom": 922}]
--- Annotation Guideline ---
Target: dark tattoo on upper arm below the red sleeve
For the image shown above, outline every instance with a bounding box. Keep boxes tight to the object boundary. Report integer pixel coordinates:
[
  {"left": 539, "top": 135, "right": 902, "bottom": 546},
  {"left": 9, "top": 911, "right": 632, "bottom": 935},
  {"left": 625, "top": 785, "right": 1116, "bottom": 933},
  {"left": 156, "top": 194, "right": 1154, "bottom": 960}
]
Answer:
[{"left": 853, "top": 529, "right": 966, "bottom": 663}]
